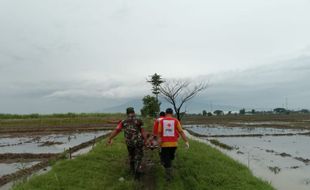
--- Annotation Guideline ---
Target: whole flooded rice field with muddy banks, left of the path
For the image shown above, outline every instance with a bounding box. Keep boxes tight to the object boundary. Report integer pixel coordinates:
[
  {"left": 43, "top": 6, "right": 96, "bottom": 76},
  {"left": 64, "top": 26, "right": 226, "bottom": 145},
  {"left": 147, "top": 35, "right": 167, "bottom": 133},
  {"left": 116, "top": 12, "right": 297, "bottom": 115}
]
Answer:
[{"left": 0, "top": 131, "right": 110, "bottom": 189}]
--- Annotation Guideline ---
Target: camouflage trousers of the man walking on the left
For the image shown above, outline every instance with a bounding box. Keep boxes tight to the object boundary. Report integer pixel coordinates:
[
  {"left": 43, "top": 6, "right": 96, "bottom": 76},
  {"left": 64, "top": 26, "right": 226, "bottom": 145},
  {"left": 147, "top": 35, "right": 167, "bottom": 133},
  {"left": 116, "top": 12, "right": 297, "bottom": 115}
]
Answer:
[{"left": 127, "top": 145, "right": 143, "bottom": 175}]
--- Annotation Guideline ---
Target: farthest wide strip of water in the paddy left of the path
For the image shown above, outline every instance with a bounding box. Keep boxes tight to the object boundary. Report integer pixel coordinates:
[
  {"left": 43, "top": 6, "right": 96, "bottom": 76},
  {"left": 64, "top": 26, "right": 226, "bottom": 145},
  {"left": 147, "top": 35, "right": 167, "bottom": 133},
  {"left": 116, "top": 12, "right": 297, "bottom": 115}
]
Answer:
[{"left": 0, "top": 131, "right": 108, "bottom": 154}]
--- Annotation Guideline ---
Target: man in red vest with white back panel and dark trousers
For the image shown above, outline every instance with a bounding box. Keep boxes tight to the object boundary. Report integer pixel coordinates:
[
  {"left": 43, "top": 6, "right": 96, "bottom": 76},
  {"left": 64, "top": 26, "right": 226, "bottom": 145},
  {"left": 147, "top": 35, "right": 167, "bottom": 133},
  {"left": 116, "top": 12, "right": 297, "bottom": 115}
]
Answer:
[{"left": 158, "top": 108, "right": 189, "bottom": 181}]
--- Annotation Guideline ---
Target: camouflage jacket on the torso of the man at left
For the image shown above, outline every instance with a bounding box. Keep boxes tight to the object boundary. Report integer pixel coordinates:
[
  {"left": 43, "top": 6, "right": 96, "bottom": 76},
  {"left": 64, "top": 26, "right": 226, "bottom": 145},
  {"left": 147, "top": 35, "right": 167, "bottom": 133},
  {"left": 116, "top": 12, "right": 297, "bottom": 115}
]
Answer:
[{"left": 121, "top": 117, "right": 144, "bottom": 146}]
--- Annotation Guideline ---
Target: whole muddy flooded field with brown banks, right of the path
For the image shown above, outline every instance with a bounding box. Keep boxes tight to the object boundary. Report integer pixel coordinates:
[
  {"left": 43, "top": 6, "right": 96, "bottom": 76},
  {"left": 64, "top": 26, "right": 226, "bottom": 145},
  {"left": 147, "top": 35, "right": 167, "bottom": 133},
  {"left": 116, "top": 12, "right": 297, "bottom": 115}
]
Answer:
[{"left": 184, "top": 116, "right": 310, "bottom": 190}]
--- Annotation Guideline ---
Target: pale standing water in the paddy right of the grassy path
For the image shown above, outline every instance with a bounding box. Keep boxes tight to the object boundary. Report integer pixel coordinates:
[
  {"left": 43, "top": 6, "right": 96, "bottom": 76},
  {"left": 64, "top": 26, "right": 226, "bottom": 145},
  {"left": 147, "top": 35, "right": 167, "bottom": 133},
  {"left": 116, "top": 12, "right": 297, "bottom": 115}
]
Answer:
[{"left": 186, "top": 125, "right": 310, "bottom": 190}]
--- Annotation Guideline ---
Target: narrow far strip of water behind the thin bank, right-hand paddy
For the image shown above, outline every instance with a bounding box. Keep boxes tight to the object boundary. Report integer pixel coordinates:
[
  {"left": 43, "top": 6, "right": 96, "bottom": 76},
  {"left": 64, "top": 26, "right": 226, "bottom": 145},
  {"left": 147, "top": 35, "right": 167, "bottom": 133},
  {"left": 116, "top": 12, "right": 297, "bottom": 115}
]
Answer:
[{"left": 184, "top": 124, "right": 310, "bottom": 136}]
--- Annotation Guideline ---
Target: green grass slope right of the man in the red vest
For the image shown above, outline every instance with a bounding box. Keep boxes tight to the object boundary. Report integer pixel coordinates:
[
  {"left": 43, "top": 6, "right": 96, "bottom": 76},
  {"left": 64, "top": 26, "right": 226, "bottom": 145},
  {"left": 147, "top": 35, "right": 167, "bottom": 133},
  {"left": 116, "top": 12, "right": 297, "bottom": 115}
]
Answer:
[{"left": 157, "top": 141, "right": 274, "bottom": 190}]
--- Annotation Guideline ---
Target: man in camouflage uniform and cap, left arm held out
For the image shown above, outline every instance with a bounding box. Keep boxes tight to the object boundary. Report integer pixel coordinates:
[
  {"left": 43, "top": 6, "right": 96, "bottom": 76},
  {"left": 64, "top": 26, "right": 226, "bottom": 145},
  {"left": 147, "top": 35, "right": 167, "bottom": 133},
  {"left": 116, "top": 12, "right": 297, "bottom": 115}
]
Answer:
[{"left": 108, "top": 107, "right": 146, "bottom": 178}]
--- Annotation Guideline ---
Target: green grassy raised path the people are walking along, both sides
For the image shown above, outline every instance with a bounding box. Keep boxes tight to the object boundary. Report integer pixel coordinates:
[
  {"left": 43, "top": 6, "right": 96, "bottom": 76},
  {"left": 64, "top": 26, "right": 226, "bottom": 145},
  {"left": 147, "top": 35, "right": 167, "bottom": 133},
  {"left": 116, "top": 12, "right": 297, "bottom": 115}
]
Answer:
[{"left": 14, "top": 134, "right": 274, "bottom": 190}]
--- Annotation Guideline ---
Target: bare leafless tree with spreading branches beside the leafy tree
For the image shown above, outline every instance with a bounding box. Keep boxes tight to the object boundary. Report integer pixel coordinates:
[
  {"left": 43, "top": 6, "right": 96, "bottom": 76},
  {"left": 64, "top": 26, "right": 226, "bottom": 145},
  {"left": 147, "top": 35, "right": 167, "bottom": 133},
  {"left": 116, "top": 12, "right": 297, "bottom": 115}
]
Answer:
[{"left": 159, "top": 80, "right": 207, "bottom": 120}]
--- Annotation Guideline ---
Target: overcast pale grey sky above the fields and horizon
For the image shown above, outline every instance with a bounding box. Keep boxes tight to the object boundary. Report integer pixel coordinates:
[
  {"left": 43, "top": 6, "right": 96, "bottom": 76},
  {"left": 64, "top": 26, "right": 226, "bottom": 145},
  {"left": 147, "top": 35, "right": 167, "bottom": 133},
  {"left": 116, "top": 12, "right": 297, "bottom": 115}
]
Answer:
[{"left": 0, "top": 0, "right": 310, "bottom": 113}]
